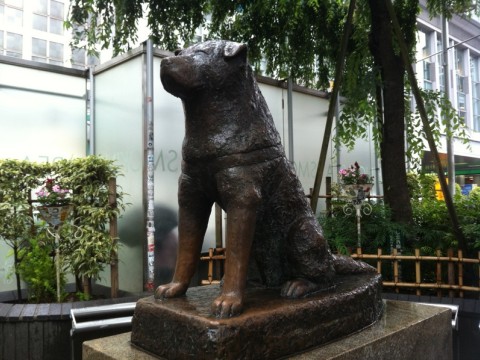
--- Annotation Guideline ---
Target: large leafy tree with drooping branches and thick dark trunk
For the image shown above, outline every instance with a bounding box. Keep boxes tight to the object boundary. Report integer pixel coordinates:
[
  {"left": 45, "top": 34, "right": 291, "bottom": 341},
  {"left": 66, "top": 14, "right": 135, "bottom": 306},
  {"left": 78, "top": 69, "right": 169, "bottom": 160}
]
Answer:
[{"left": 66, "top": 0, "right": 470, "bottom": 228}]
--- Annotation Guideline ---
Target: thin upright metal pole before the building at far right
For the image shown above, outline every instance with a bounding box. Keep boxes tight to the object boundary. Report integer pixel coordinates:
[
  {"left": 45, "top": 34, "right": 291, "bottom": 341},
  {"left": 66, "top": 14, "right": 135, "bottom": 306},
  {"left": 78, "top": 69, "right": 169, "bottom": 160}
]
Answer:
[{"left": 442, "top": 15, "right": 455, "bottom": 196}]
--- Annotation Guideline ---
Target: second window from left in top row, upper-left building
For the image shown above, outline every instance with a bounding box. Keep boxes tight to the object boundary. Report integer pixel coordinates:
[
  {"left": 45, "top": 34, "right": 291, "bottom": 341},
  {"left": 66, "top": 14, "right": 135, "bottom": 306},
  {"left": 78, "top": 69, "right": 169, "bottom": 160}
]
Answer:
[{"left": 33, "top": 0, "right": 64, "bottom": 35}]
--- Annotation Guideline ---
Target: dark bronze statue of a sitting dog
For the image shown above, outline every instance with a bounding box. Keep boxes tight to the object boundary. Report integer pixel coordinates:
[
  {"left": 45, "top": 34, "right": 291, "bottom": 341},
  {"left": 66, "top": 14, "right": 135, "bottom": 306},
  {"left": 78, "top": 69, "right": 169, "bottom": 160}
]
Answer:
[{"left": 155, "top": 41, "right": 372, "bottom": 318}]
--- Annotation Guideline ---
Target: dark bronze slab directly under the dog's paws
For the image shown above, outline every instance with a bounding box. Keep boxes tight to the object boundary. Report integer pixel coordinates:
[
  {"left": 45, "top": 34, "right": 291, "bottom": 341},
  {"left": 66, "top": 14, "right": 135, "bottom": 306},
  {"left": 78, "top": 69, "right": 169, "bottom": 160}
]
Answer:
[{"left": 131, "top": 273, "right": 383, "bottom": 360}]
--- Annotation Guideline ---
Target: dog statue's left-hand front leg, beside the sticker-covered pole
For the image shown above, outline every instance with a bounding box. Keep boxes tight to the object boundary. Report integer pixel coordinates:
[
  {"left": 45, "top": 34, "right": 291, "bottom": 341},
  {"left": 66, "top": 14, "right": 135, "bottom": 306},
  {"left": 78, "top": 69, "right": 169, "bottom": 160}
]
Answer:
[{"left": 155, "top": 203, "right": 212, "bottom": 299}]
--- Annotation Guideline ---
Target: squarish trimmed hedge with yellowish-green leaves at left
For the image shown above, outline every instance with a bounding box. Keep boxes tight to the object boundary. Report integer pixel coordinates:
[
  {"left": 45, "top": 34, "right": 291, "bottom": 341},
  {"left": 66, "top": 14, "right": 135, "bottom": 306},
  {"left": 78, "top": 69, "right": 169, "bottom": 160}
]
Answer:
[{"left": 0, "top": 156, "right": 126, "bottom": 298}]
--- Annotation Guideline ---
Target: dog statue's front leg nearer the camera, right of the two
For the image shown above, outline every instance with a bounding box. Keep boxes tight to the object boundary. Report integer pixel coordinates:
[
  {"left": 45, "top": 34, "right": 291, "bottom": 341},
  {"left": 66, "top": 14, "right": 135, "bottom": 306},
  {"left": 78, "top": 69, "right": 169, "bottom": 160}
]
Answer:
[{"left": 212, "top": 207, "right": 256, "bottom": 318}]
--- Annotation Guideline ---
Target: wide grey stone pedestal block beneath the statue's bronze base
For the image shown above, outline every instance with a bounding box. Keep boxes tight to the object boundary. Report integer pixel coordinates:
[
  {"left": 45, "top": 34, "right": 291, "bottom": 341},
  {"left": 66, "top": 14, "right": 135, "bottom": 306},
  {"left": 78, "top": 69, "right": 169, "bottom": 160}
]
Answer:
[{"left": 83, "top": 300, "right": 453, "bottom": 360}]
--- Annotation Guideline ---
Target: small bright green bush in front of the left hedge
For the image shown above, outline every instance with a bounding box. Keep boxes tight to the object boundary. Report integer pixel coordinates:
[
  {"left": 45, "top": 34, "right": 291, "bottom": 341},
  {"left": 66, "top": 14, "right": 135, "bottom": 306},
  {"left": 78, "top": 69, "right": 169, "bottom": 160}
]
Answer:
[{"left": 18, "top": 235, "right": 65, "bottom": 303}]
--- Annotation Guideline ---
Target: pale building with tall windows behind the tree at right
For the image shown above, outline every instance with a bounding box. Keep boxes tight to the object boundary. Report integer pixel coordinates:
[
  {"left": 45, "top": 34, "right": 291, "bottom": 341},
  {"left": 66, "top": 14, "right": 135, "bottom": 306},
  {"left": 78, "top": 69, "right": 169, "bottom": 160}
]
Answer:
[{"left": 415, "top": 0, "right": 480, "bottom": 188}]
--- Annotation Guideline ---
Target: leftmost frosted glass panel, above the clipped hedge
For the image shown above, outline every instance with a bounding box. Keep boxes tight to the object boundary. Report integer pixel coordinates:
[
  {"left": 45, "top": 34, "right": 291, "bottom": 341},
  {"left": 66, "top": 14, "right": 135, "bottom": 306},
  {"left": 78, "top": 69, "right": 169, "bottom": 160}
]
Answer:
[{"left": 0, "top": 64, "right": 86, "bottom": 162}]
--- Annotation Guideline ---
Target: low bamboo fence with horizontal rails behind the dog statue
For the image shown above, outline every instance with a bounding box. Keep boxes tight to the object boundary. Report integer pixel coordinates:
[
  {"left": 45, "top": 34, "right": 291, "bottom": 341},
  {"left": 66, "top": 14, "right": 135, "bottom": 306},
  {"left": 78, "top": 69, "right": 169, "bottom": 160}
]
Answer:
[{"left": 200, "top": 248, "right": 480, "bottom": 298}]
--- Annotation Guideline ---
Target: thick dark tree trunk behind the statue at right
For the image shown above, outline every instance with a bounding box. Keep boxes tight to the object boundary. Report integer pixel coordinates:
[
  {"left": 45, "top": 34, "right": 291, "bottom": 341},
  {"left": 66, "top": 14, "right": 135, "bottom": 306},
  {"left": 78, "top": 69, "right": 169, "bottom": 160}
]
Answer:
[{"left": 369, "top": 0, "right": 412, "bottom": 224}]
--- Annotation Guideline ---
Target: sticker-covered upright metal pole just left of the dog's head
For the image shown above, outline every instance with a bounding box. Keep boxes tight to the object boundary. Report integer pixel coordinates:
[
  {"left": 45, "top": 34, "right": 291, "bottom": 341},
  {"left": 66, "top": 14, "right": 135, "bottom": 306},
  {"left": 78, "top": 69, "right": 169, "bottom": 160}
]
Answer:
[{"left": 144, "top": 39, "right": 155, "bottom": 291}]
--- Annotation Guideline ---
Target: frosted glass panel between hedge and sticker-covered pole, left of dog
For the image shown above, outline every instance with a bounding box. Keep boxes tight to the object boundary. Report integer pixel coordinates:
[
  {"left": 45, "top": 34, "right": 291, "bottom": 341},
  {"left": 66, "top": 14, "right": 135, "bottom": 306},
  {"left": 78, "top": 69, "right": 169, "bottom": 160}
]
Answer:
[{"left": 95, "top": 56, "right": 145, "bottom": 292}]
